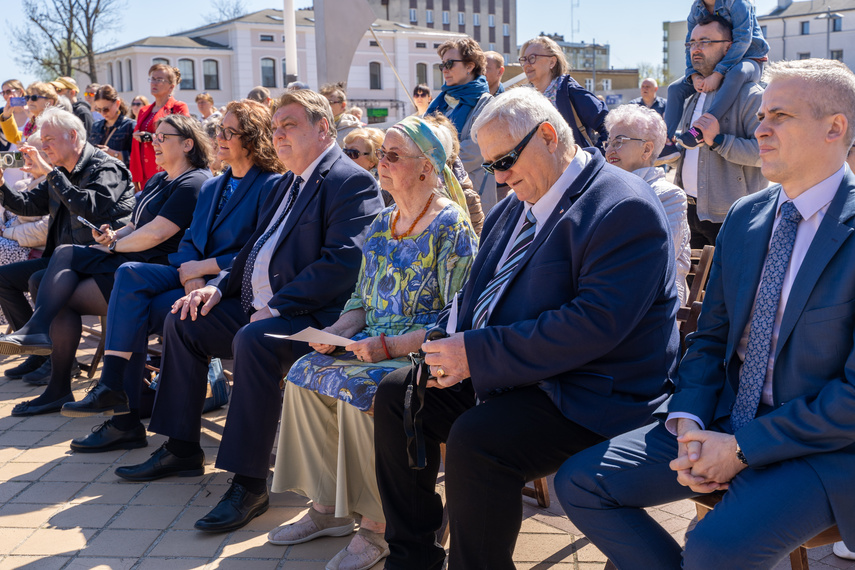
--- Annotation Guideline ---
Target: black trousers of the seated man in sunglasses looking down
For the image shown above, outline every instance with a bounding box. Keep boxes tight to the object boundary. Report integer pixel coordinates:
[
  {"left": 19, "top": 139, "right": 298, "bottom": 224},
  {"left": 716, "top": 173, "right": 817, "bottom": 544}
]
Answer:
[{"left": 374, "top": 368, "right": 604, "bottom": 570}]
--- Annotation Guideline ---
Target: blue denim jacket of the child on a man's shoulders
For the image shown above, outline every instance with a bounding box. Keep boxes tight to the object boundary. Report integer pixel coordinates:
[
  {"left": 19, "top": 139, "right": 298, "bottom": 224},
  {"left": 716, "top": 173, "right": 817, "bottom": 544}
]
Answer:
[{"left": 686, "top": 0, "right": 769, "bottom": 81}]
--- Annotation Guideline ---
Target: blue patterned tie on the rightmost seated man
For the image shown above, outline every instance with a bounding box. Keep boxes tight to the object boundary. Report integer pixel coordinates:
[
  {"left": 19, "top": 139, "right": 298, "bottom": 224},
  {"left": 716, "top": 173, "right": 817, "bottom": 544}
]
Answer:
[{"left": 730, "top": 201, "right": 802, "bottom": 432}]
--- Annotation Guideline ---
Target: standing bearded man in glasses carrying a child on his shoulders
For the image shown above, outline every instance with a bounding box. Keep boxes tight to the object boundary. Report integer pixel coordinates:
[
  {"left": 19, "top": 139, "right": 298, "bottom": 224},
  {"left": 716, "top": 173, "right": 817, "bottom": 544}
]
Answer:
[{"left": 674, "top": 16, "right": 768, "bottom": 249}]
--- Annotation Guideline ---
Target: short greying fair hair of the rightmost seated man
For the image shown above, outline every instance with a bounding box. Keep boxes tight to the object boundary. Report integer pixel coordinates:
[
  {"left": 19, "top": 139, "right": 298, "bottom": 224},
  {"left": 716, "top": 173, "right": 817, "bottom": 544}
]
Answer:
[{"left": 763, "top": 58, "right": 855, "bottom": 148}]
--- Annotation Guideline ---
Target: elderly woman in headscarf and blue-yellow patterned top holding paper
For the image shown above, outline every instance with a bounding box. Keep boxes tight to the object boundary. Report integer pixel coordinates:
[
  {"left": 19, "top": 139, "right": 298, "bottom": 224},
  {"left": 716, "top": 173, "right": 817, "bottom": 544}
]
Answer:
[{"left": 268, "top": 117, "right": 477, "bottom": 570}]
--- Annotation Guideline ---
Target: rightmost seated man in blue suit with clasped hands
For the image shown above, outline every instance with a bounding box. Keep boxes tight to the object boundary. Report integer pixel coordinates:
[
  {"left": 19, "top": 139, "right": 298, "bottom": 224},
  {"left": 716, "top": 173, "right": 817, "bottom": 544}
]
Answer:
[{"left": 555, "top": 59, "right": 855, "bottom": 569}]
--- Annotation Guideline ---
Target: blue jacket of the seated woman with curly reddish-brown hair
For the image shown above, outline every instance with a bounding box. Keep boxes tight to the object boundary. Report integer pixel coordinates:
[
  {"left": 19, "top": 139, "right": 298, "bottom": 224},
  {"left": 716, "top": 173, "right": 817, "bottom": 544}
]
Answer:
[{"left": 169, "top": 166, "right": 282, "bottom": 269}]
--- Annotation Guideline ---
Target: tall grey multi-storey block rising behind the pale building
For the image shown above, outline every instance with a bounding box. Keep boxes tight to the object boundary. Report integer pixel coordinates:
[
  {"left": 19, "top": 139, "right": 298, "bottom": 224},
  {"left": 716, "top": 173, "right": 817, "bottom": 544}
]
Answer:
[{"left": 368, "top": 0, "right": 519, "bottom": 63}]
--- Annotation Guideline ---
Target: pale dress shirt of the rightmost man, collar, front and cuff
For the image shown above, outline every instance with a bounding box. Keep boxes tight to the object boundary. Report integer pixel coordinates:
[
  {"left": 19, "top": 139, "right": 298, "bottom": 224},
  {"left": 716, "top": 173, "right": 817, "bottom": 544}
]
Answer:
[{"left": 665, "top": 164, "right": 846, "bottom": 433}]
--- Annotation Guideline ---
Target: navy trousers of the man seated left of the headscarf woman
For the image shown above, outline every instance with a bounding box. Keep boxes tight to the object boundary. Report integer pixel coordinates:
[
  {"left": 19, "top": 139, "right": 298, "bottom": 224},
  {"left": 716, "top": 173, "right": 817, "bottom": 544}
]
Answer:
[{"left": 148, "top": 297, "right": 318, "bottom": 478}]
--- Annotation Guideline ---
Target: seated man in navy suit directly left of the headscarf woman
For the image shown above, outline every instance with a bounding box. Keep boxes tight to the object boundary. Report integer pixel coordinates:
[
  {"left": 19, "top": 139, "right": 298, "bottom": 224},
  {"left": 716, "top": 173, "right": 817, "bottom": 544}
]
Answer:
[{"left": 116, "top": 90, "right": 382, "bottom": 532}]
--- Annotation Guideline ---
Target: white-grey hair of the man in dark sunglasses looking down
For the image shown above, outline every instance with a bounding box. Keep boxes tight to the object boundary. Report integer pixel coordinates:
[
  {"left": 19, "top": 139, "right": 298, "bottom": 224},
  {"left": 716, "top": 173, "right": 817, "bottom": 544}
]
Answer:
[{"left": 472, "top": 87, "right": 575, "bottom": 148}]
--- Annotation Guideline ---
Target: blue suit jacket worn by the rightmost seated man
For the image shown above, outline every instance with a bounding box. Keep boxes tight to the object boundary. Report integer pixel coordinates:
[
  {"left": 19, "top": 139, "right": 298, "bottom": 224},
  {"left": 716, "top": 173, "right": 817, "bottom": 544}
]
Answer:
[{"left": 669, "top": 171, "right": 855, "bottom": 544}]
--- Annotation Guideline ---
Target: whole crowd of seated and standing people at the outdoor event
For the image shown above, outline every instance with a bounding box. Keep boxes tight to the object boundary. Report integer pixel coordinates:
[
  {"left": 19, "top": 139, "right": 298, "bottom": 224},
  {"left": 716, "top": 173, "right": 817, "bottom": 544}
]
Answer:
[{"left": 0, "top": 0, "right": 855, "bottom": 570}]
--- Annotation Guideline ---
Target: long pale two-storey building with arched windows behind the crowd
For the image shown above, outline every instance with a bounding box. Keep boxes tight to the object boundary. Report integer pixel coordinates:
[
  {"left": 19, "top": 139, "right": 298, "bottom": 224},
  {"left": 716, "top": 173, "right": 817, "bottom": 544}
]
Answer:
[{"left": 76, "top": 10, "right": 462, "bottom": 122}]
